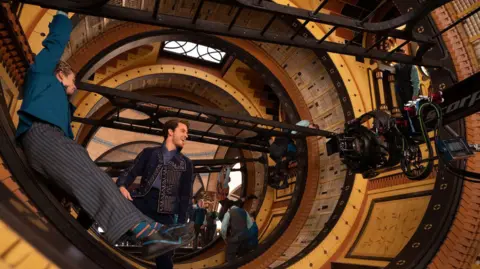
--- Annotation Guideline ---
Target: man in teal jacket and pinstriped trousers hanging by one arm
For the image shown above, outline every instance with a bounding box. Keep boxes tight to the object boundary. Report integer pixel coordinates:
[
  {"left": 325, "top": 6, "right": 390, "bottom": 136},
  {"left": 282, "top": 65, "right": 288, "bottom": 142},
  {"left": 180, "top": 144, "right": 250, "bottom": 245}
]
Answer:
[{"left": 16, "top": 11, "right": 193, "bottom": 258}]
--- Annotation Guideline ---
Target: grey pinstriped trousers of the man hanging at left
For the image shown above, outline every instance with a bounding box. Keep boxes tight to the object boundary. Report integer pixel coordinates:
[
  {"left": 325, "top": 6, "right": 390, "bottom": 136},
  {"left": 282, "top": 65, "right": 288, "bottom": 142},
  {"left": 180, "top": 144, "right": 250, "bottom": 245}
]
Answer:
[{"left": 21, "top": 122, "right": 151, "bottom": 244}]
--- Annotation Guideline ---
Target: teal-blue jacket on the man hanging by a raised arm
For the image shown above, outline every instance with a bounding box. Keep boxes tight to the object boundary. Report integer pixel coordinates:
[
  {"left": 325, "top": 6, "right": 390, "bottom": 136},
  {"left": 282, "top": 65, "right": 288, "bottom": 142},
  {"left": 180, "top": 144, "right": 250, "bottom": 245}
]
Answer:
[{"left": 16, "top": 15, "right": 75, "bottom": 138}]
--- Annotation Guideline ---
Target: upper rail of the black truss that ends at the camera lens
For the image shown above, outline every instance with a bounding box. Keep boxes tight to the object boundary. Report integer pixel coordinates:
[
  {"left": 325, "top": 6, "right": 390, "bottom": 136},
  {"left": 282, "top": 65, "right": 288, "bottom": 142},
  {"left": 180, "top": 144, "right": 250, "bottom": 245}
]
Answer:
[{"left": 77, "top": 82, "right": 334, "bottom": 137}]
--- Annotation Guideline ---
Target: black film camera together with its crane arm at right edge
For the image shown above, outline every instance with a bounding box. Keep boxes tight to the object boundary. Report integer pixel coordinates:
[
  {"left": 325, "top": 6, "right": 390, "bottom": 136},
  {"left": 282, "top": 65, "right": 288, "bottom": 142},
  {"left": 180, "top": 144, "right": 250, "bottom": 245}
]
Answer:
[{"left": 326, "top": 73, "right": 480, "bottom": 180}]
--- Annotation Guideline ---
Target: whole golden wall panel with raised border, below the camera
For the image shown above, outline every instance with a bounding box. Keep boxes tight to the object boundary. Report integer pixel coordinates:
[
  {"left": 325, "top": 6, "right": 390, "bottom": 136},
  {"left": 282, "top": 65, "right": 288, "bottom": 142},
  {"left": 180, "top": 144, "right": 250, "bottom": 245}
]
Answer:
[{"left": 336, "top": 178, "right": 435, "bottom": 266}]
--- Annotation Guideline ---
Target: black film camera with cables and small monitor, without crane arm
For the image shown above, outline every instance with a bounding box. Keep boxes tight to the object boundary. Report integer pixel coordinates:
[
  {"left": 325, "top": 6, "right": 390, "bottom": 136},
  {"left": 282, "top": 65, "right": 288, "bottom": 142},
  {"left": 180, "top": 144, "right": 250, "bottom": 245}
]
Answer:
[{"left": 326, "top": 92, "right": 473, "bottom": 180}]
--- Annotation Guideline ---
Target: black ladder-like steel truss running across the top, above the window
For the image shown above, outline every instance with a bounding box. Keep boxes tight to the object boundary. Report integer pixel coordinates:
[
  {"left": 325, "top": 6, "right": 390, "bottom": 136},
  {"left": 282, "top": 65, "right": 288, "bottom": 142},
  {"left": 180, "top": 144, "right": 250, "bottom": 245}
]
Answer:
[{"left": 0, "top": 0, "right": 462, "bottom": 67}]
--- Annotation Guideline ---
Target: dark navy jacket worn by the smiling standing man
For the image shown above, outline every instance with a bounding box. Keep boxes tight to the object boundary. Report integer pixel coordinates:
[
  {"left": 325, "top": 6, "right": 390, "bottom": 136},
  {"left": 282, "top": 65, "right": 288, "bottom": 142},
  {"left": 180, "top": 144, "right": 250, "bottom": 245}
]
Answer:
[{"left": 117, "top": 147, "right": 193, "bottom": 223}]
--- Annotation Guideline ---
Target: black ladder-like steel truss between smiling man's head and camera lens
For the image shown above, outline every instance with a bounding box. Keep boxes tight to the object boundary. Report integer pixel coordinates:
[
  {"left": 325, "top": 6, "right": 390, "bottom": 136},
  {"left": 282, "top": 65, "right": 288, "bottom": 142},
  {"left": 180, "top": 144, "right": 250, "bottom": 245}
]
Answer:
[{"left": 72, "top": 82, "right": 334, "bottom": 153}]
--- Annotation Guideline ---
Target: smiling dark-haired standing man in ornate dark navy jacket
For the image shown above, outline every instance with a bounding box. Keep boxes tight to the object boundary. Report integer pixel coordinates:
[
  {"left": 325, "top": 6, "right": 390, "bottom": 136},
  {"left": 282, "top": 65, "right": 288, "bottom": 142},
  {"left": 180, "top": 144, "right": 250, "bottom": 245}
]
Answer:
[{"left": 117, "top": 120, "right": 194, "bottom": 269}]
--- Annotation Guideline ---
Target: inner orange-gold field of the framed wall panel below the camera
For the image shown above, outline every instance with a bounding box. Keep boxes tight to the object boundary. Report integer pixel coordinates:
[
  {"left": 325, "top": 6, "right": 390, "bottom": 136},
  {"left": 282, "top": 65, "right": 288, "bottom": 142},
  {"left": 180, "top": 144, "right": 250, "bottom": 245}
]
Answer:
[{"left": 347, "top": 191, "right": 431, "bottom": 260}]
